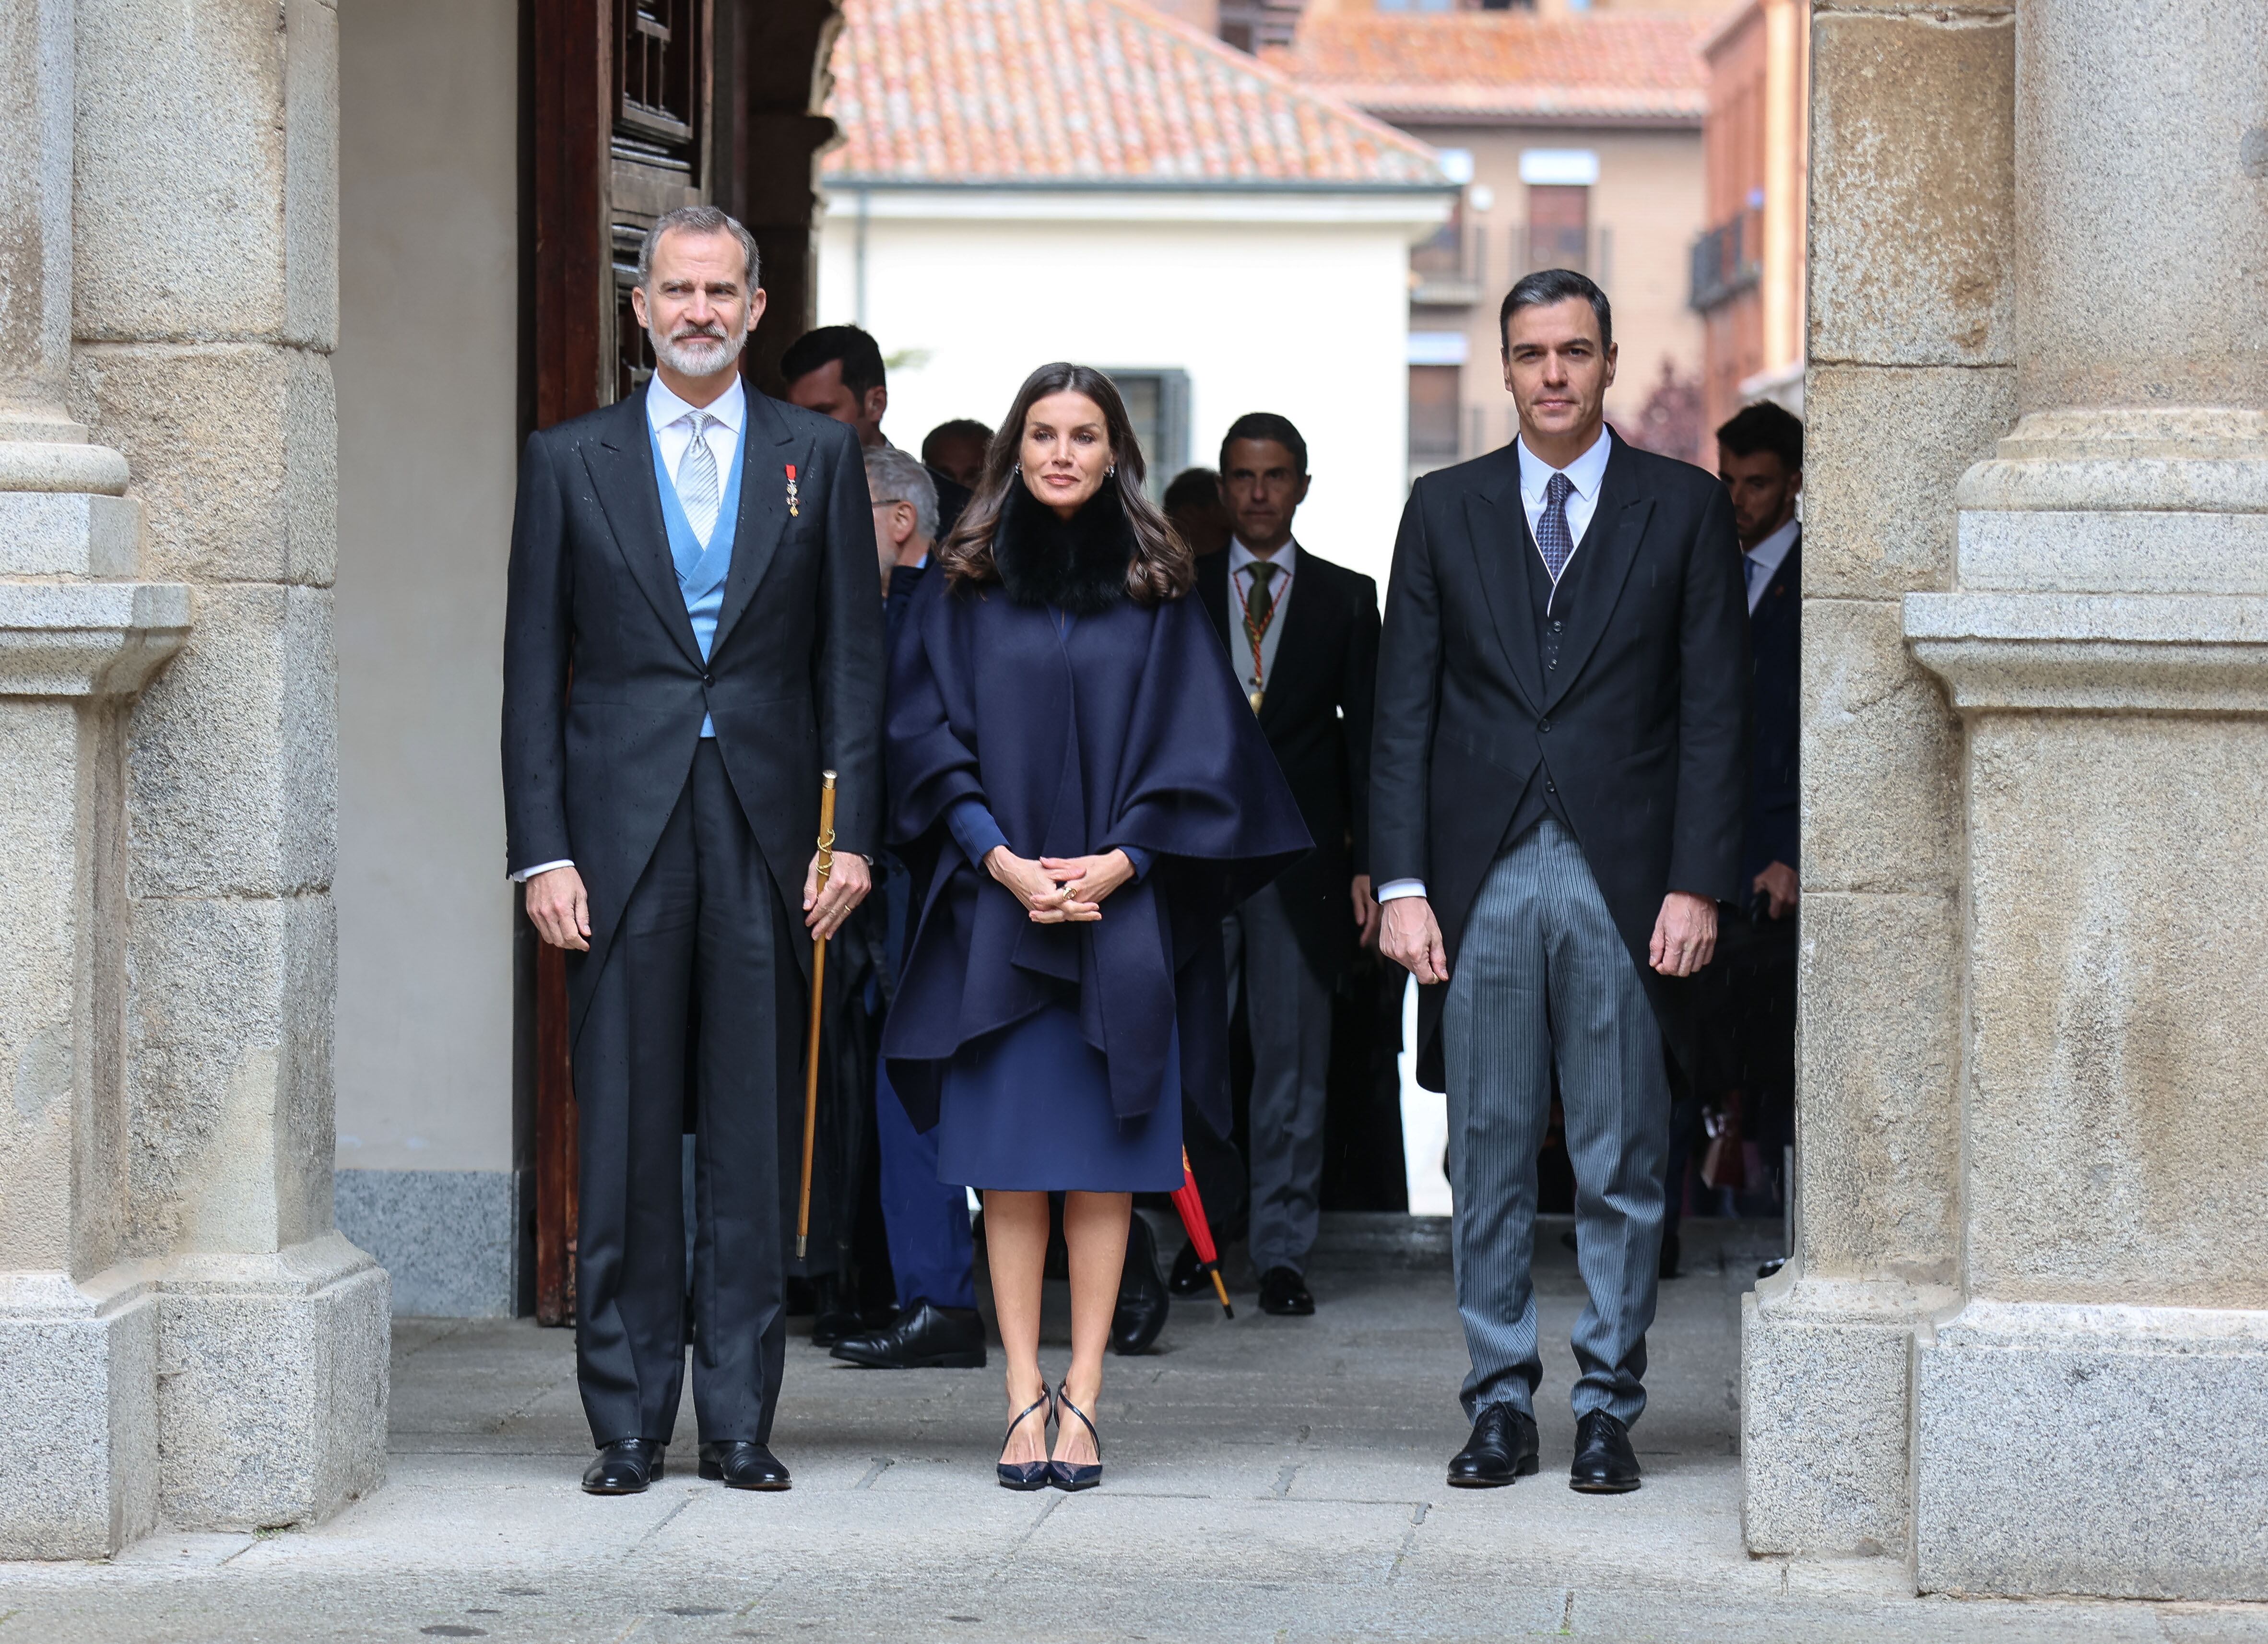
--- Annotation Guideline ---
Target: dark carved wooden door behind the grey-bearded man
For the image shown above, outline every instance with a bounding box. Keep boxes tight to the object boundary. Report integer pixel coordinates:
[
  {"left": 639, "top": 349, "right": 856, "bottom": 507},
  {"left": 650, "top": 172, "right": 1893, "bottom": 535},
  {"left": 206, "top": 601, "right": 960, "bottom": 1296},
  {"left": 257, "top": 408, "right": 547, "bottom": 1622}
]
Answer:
[{"left": 521, "top": 0, "right": 839, "bottom": 1325}]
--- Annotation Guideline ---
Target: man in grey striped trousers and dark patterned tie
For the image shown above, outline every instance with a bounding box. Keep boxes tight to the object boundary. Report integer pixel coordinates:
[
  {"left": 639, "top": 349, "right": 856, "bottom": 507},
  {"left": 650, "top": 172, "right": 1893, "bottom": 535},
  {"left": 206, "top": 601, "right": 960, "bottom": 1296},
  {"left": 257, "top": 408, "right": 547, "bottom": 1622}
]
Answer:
[{"left": 1370, "top": 270, "right": 1748, "bottom": 1492}]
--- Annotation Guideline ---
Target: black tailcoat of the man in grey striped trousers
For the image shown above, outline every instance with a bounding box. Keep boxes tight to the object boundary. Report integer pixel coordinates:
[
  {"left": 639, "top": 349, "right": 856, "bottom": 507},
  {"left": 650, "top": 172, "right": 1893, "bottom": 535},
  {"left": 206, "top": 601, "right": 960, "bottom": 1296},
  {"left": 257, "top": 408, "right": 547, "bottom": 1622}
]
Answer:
[{"left": 1370, "top": 436, "right": 1748, "bottom": 1091}]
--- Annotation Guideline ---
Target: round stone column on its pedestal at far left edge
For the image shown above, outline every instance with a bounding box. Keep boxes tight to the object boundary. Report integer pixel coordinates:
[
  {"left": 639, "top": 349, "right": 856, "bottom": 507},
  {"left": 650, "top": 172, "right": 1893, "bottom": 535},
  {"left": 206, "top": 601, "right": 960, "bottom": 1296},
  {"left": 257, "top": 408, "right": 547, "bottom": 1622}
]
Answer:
[{"left": 0, "top": 0, "right": 188, "bottom": 1558}]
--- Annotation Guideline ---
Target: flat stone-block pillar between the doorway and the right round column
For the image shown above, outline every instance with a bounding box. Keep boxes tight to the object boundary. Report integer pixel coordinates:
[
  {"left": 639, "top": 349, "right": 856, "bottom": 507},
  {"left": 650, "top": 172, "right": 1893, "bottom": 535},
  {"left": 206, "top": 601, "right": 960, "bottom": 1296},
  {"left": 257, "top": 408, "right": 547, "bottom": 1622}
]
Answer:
[{"left": 1739, "top": 0, "right": 2016, "bottom": 1556}]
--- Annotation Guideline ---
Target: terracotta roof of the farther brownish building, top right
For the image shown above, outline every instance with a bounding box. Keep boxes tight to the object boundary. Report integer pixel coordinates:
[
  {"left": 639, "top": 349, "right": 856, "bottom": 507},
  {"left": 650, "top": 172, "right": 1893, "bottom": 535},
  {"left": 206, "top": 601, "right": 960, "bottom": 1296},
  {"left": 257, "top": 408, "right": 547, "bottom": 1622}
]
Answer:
[{"left": 1263, "top": 12, "right": 1717, "bottom": 125}]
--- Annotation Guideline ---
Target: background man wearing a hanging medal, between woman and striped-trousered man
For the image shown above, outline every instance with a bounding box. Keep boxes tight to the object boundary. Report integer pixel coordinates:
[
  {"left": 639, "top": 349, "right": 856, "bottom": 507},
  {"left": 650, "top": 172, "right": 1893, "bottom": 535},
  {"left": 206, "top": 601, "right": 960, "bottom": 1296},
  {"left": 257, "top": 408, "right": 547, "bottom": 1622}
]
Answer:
[{"left": 1177, "top": 413, "right": 1379, "bottom": 1315}]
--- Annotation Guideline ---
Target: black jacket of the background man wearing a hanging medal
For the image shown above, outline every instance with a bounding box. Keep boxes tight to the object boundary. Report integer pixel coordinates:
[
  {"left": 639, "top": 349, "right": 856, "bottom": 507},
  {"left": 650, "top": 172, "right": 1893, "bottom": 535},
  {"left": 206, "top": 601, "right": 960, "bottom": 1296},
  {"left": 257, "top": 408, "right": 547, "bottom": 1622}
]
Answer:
[{"left": 1197, "top": 546, "right": 1379, "bottom": 982}]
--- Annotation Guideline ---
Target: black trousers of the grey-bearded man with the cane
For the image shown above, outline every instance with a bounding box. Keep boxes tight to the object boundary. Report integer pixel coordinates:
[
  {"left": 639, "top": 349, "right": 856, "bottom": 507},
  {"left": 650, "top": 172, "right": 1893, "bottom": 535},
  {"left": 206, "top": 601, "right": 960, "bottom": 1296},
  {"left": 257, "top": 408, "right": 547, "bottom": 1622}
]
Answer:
[{"left": 574, "top": 739, "right": 807, "bottom": 1444}]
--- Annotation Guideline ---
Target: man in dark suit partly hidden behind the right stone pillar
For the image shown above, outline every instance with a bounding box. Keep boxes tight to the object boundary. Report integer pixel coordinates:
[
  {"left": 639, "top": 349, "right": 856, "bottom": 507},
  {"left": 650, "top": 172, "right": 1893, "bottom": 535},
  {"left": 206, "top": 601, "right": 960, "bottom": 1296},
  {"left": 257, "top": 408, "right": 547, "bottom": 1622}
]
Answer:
[{"left": 1663, "top": 402, "right": 1803, "bottom": 1279}]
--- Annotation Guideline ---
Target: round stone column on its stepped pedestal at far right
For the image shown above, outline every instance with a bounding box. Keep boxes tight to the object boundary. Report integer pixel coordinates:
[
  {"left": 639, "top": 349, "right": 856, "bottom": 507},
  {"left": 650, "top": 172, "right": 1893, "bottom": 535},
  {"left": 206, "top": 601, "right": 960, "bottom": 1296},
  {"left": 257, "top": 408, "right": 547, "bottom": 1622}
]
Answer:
[{"left": 1905, "top": 0, "right": 2268, "bottom": 1598}]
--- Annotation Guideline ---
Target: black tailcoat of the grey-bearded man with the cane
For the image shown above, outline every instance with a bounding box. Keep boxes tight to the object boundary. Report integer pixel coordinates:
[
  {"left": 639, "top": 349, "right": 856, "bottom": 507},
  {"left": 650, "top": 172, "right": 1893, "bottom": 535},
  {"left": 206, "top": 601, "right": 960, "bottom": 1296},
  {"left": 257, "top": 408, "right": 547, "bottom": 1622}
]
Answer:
[{"left": 504, "top": 388, "right": 887, "bottom": 1023}]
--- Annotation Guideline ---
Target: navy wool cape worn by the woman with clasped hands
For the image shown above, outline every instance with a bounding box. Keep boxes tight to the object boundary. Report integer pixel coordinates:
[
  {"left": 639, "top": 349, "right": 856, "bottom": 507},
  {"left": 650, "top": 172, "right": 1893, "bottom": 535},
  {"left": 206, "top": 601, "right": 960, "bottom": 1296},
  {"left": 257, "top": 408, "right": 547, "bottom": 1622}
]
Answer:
[{"left": 882, "top": 574, "right": 1311, "bottom": 1134}]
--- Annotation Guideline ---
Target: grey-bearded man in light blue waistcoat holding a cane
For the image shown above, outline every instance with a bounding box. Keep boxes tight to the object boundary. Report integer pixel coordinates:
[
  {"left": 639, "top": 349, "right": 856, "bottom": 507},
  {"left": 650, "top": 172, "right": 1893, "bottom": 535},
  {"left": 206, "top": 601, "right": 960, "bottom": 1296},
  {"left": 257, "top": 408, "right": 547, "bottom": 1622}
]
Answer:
[{"left": 504, "top": 206, "right": 882, "bottom": 1494}]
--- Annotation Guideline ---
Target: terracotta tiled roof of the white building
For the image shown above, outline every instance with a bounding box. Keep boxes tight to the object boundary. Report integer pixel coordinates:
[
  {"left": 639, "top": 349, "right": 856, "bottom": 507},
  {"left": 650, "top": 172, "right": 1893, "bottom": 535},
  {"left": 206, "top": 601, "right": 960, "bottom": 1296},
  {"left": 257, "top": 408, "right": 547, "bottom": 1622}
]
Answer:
[{"left": 826, "top": 0, "right": 1440, "bottom": 188}]
